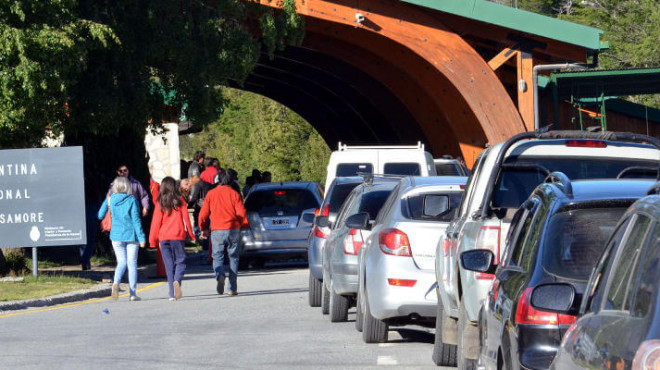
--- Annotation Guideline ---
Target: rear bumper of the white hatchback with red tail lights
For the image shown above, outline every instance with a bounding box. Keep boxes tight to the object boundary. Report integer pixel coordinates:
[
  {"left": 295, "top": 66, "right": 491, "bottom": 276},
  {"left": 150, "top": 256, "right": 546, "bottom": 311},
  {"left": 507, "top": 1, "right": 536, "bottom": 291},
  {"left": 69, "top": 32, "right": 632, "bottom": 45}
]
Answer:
[{"left": 367, "top": 266, "right": 438, "bottom": 320}]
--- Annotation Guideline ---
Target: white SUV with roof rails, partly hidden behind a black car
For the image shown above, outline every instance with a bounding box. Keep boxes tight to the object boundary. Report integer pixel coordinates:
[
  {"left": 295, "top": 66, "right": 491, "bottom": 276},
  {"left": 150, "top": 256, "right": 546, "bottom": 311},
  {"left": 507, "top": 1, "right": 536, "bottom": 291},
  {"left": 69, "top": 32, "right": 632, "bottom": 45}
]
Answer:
[{"left": 436, "top": 131, "right": 660, "bottom": 368}]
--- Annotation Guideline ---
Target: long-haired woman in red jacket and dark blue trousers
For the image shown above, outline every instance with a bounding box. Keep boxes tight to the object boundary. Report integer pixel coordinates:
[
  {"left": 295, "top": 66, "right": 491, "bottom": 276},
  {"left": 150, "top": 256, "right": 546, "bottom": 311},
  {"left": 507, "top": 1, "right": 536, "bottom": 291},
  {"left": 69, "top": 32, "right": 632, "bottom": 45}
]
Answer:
[{"left": 149, "top": 176, "right": 195, "bottom": 301}]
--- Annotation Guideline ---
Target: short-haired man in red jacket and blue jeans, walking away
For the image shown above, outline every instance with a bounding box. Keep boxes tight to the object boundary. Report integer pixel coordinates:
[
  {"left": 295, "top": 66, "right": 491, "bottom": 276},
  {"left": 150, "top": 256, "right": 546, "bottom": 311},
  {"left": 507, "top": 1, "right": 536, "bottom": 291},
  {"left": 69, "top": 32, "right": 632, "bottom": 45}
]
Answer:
[{"left": 199, "top": 171, "right": 247, "bottom": 295}]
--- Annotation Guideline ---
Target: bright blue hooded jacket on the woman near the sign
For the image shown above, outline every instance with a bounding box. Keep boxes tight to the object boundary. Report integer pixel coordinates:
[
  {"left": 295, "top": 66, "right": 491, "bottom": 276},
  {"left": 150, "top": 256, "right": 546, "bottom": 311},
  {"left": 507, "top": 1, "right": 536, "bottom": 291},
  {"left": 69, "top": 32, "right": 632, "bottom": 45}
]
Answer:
[{"left": 97, "top": 193, "right": 146, "bottom": 242}]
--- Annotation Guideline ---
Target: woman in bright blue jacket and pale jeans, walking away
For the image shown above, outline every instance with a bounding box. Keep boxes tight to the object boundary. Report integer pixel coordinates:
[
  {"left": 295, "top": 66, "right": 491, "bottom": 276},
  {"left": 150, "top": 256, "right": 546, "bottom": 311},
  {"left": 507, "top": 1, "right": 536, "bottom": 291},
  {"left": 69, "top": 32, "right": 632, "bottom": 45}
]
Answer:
[{"left": 97, "top": 176, "right": 146, "bottom": 301}]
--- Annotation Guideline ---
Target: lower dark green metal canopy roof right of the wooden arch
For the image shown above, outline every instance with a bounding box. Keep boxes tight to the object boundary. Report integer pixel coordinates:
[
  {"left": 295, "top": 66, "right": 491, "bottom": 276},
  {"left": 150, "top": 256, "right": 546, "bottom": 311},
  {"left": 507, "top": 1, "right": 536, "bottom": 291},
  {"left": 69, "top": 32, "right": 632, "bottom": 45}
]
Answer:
[{"left": 547, "top": 68, "right": 660, "bottom": 99}]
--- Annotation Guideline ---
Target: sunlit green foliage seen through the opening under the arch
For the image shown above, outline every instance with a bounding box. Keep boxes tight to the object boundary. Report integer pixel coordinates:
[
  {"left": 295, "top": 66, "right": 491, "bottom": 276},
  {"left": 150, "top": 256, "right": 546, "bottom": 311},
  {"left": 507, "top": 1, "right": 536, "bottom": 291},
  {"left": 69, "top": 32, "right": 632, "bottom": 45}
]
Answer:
[{"left": 181, "top": 88, "right": 330, "bottom": 183}]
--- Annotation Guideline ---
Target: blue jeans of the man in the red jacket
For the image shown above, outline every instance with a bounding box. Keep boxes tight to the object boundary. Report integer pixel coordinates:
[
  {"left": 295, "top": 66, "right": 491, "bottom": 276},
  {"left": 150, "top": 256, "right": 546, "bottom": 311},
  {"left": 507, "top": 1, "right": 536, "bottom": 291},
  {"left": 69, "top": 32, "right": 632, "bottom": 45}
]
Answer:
[{"left": 211, "top": 229, "right": 241, "bottom": 292}]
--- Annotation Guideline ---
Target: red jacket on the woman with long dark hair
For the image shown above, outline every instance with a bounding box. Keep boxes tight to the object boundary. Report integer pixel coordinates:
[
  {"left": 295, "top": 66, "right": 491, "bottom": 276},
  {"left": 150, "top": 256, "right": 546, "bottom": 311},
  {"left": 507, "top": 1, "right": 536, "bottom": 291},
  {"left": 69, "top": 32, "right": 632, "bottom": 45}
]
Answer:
[{"left": 149, "top": 198, "right": 195, "bottom": 248}]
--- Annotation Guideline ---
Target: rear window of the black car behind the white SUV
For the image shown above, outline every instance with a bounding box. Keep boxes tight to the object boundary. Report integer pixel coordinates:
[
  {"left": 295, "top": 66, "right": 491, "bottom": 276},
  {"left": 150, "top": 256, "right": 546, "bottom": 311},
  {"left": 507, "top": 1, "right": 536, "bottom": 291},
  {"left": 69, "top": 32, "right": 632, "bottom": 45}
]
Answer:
[{"left": 542, "top": 207, "right": 626, "bottom": 281}]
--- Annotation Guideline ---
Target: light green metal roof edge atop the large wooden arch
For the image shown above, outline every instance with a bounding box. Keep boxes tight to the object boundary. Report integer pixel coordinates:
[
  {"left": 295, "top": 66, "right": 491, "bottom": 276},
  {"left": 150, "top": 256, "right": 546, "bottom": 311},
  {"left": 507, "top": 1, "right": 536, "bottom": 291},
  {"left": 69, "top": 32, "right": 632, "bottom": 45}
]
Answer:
[{"left": 402, "top": 0, "right": 609, "bottom": 50}]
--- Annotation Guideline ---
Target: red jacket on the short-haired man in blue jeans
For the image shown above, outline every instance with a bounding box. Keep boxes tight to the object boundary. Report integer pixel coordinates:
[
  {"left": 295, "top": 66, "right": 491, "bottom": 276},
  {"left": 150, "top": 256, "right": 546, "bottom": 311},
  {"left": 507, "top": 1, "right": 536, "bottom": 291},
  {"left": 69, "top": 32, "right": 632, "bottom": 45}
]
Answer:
[{"left": 199, "top": 185, "right": 247, "bottom": 231}]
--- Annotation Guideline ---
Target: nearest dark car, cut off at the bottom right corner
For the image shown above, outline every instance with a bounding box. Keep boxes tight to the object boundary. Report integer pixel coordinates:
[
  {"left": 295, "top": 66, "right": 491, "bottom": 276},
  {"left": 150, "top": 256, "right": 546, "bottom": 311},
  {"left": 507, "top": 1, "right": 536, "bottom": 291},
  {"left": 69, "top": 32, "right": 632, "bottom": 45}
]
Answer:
[{"left": 530, "top": 184, "right": 660, "bottom": 369}]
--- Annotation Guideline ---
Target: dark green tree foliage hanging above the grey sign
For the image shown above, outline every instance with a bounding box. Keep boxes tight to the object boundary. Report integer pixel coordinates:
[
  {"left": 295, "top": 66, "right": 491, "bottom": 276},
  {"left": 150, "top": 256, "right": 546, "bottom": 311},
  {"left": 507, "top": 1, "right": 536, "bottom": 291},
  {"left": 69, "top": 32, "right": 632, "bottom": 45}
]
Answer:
[{"left": 0, "top": 0, "right": 304, "bottom": 148}]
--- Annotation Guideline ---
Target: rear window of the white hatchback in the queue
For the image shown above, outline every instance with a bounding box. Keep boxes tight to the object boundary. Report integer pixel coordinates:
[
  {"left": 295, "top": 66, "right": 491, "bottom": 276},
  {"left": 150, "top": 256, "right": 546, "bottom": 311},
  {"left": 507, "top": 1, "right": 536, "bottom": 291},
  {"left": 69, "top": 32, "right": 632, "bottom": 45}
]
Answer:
[{"left": 401, "top": 192, "right": 463, "bottom": 222}]
